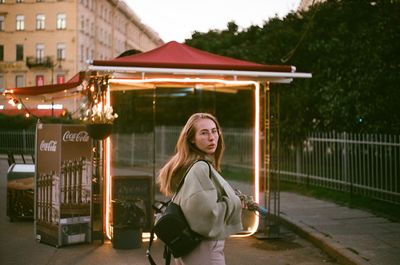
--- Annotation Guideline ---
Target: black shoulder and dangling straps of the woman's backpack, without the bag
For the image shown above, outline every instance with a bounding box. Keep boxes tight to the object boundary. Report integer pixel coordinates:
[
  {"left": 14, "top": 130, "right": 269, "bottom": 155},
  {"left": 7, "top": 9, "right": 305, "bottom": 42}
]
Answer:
[{"left": 146, "top": 159, "right": 211, "bottom": 265}]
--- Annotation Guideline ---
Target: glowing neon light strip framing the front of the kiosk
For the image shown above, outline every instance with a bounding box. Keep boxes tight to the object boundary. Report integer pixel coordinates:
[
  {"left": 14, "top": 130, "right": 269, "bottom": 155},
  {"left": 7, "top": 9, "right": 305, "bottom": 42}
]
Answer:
[{"left": 105, "top": 78, "right": 260, "bottom": 239}]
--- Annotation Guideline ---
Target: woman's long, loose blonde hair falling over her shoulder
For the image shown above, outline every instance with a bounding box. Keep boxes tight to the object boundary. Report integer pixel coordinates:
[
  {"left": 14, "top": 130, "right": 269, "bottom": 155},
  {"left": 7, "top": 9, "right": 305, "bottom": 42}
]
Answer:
[{"left": 158, "top": 113, "right": 225, "bottom": 196}]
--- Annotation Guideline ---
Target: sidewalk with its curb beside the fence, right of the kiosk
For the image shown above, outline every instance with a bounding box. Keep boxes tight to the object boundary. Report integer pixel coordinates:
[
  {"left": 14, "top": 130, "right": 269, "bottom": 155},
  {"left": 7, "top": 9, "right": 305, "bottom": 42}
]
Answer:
[{"left": 281, "top": 192, "right": 400, "bottom": 265}]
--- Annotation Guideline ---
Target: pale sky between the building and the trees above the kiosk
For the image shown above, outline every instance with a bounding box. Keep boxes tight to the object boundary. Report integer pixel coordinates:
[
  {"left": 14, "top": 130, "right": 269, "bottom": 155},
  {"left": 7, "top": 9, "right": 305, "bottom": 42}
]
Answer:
[{"left": 124, "top": 0, "right": 300, "bottom": 42}]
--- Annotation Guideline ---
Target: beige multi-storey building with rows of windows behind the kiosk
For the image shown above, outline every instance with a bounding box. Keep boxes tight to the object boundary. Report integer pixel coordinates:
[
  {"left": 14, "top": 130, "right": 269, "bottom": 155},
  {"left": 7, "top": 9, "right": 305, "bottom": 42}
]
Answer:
[{"left": 0, "top": 0, "right": 163, "bottom": 92}]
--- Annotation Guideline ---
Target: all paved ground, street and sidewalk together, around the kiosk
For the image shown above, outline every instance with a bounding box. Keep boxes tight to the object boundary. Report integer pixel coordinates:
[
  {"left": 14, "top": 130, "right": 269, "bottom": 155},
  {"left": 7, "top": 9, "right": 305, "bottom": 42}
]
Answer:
[{"left": 0, "top": 157, "right": 400, "bottom": 265}]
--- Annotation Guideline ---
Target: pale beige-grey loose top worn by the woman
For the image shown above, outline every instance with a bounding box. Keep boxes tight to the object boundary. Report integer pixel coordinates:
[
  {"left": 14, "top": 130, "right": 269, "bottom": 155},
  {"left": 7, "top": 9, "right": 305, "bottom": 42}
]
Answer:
[{"left": 174, "top": 161, "right": 242, "bottom": 240}]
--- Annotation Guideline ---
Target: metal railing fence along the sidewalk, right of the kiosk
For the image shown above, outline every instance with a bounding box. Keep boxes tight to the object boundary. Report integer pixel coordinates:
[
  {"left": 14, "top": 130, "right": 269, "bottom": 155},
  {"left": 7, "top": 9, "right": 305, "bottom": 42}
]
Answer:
[{"left": 278, "top": 132, "right": 400, "bottom": 204}]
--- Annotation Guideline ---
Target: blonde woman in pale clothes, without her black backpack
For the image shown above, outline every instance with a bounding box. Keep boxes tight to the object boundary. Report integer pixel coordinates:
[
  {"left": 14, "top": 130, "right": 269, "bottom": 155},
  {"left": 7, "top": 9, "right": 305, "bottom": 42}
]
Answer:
[{"left": 158, "top": 113, "right": 242, "bottom": 265}]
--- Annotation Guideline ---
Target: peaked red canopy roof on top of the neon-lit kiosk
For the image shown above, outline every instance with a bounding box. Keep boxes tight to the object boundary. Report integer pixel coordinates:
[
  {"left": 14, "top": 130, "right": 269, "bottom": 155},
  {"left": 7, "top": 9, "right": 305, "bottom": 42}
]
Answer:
[{"left": 93, "top": 41, "right": 292, "bottom": 72}]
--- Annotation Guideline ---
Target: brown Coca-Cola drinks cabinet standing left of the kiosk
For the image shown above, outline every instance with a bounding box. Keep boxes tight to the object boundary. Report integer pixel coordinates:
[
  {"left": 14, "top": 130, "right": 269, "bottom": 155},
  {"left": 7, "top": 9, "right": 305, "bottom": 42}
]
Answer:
[{"left": 35, "top": 123, "right": 92, "bottom": 247}]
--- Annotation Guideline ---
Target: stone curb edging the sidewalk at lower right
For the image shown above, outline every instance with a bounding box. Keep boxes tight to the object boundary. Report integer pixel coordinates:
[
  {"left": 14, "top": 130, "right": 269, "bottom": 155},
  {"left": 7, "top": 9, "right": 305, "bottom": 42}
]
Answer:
[{"left": 278, "top": 213, "right": 368, "bottom": 265}]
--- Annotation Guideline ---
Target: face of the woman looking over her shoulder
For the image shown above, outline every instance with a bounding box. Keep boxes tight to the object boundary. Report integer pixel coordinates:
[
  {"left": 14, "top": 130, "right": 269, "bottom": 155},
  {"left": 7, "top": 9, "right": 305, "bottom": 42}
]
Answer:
[{"left": 192, "top": 118, "right": 219, "bottom": 155}]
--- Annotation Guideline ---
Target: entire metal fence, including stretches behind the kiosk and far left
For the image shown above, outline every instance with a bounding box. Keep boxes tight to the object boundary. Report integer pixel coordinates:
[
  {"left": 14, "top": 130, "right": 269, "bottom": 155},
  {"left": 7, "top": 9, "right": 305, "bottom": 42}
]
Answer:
[{"left": 0, "top": 126, "right": 400, "bottom": 204}]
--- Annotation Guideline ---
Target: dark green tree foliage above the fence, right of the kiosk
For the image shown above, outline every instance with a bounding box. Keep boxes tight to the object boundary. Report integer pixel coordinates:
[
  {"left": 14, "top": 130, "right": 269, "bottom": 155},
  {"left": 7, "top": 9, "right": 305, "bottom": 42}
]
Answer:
[{"left": 186, "top": 0, "right": 400, "bottom": 137}]
